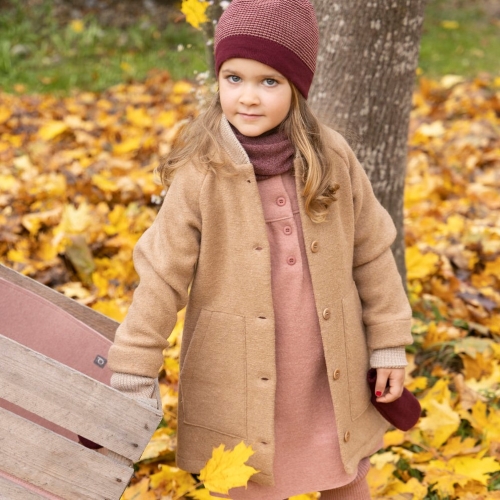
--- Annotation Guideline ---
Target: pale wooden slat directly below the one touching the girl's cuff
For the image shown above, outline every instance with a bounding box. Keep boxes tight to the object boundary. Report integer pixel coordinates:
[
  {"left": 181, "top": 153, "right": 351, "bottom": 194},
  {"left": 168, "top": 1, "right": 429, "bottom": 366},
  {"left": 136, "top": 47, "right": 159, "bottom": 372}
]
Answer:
[{"left": 0, "top": 408, "right": 133, "bottom": 500}]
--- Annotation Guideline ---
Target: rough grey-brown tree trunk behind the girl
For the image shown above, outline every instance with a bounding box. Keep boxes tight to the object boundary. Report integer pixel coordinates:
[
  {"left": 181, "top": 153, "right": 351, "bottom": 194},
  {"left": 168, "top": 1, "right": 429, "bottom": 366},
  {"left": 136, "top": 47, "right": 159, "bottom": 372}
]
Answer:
[{"left": 309, "top": 0, "right": 424, "bottom": 286}]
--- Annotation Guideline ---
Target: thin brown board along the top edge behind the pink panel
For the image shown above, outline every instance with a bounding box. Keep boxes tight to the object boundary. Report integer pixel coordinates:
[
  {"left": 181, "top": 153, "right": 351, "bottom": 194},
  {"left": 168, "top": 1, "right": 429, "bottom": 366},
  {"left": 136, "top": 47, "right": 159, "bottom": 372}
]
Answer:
[{"left": 0, "top": 264, "right": 119, "bottom": 341}]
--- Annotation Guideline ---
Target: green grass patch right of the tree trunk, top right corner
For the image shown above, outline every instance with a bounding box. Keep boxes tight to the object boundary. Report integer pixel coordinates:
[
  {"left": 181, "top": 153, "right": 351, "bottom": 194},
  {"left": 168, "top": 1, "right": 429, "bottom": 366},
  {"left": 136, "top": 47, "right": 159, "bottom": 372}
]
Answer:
[{"left": 419, "top": 0, "right": 500, "bottom": 78}]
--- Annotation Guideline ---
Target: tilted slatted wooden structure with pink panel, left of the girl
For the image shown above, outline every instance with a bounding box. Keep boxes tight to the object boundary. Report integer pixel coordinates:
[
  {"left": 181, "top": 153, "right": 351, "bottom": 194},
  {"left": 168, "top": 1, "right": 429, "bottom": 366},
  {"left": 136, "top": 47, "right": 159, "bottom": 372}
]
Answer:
[{"left": 0, "top": 265, "right": 162, "bottom": 500}]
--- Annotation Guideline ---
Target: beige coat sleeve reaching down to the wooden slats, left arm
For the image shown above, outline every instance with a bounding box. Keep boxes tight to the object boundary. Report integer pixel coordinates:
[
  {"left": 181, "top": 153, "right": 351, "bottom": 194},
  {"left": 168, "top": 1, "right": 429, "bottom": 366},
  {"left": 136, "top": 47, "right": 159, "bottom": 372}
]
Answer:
[{"left": 108, "top": 166, "right": 205, "bottom": 378}]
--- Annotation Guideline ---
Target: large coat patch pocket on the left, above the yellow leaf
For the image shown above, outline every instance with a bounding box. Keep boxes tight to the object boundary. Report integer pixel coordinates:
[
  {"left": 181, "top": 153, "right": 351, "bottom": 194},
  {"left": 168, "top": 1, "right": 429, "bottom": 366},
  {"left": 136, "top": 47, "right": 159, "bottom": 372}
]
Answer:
[{"left": 180, "top": 309, "right": 247, "bottom": 438}]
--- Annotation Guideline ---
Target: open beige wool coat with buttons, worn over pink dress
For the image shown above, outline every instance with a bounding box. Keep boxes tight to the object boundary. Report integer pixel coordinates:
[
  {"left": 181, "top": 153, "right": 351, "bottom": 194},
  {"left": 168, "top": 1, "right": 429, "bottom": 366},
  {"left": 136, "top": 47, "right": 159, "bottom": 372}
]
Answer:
[{"left": 109, "top": 118, "right": 412, "bottom": 485}]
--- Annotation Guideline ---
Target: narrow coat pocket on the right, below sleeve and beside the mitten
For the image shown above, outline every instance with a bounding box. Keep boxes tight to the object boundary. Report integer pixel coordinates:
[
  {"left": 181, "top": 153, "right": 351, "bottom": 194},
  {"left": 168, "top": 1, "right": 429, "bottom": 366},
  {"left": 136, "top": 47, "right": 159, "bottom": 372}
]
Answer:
[{"left": 342, "top": 283, "right": 371, "bottom": 420}]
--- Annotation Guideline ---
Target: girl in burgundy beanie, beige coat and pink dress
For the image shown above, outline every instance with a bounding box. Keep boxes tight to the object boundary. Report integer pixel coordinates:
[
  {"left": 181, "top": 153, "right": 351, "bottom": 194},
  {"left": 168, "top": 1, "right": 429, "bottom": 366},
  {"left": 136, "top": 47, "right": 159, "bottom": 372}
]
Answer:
[{"left": 109, "top": 0, "right": 412, "bottom": 500}]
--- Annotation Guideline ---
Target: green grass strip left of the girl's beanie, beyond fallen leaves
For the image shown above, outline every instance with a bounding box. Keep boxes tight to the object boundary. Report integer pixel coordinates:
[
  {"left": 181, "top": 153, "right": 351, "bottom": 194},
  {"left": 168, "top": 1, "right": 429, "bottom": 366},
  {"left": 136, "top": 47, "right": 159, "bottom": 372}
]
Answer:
[{"left": 0, "top": 0, "right": 206, "bottom": 94}]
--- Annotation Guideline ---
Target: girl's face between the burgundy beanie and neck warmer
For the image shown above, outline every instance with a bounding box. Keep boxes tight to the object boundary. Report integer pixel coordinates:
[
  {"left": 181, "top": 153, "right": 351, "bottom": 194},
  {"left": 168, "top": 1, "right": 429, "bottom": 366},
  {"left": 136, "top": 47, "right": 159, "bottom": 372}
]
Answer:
[{"left": 219, "top": 58, "right": 292, "bottom": 137}]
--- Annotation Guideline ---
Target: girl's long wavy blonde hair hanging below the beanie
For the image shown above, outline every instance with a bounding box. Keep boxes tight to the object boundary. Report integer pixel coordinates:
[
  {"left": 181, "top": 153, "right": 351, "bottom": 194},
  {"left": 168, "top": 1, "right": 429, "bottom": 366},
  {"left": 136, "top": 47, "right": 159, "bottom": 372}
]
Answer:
[{"left": 157, "top": 83, "right": 340, "bottom": 222}]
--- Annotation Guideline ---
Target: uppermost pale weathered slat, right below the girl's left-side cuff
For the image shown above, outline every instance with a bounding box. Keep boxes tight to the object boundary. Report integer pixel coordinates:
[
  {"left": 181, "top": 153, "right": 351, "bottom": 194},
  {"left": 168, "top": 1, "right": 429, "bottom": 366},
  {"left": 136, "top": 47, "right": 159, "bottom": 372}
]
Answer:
[{"left": 0, "top": 335, "right": 162, "bottom": 462}]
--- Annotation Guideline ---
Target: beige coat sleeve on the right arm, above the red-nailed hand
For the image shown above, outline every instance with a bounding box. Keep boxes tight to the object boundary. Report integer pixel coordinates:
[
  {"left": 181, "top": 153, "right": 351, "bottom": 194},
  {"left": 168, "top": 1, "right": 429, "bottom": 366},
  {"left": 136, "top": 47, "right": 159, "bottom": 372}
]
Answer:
[{"left": 343, "top": 135, "right": 413, "bottom": 350}]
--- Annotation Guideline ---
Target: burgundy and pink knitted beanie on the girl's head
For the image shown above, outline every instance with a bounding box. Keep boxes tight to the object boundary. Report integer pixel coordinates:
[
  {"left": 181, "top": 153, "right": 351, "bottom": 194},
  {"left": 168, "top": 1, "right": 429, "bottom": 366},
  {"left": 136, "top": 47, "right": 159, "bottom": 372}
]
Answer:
[{"left": 215, "top": 0, "right": 319, "bottom": 99}]
